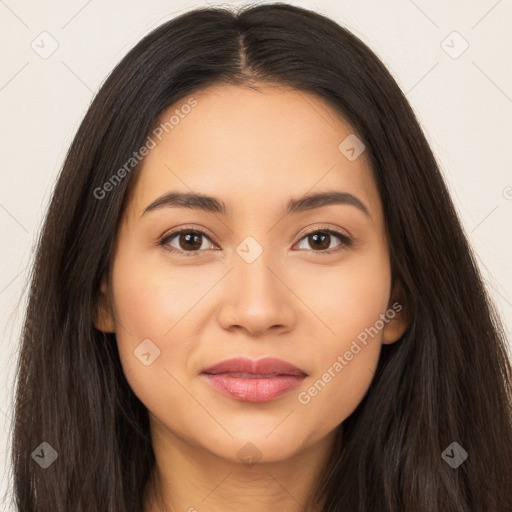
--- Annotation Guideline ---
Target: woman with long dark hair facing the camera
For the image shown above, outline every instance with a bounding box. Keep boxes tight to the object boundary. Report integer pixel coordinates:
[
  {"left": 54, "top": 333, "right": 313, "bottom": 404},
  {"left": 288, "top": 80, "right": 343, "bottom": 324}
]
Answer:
[{"left": 9, "top": 4, "right": 512, "bottom": 512}]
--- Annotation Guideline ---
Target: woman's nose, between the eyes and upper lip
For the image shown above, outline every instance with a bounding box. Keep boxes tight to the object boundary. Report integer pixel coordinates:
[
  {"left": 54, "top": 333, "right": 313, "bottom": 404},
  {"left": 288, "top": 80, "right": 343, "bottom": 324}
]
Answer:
[{"left": 218, "top": 251, "right": 297, "bottom": 336}]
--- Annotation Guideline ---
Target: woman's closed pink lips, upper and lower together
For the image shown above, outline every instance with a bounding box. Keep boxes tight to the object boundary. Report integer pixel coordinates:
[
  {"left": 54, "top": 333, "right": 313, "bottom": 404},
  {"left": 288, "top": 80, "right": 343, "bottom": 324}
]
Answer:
[{"left": 201, "top": 357, "right": 307, "bottom": 402}]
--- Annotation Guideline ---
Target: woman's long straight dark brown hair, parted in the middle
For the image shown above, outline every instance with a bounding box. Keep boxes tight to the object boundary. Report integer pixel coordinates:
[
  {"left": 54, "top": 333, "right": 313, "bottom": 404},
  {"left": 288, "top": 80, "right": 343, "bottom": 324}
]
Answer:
[{"left": 12, "top": 3, "right": 512, "bottom": 512}]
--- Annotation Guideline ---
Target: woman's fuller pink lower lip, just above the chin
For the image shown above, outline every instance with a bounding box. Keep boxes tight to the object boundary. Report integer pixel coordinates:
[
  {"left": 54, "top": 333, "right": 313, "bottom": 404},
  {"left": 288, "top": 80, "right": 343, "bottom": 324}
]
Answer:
[{"left": 203, "top": 373, "right": 305, "bottom": 402}]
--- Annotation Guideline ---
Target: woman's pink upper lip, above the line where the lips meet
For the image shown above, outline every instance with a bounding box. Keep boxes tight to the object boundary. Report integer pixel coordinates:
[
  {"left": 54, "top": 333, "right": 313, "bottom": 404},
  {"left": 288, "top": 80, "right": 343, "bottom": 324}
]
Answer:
[{"left": 202, "top": 357, "right": 307, "bottom": 375}]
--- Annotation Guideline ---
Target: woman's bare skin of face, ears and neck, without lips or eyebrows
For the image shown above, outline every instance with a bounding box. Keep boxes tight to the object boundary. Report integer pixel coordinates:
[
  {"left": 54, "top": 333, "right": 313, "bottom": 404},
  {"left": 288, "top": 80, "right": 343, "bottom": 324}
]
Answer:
[{"left": 96, "top": 84, "right": 407, "bottom": 512}]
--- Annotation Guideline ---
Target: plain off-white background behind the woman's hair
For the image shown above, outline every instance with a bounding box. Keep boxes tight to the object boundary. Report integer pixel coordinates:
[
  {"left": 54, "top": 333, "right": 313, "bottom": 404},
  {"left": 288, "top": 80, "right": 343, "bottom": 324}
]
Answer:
[{"left": 0, "top": 0, "right": 512, "bottom": 510}]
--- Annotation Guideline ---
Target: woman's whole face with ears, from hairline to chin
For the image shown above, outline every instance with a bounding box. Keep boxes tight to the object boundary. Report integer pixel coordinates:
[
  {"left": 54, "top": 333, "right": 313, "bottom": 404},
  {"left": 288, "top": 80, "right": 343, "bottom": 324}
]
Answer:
[{"left": 97, "top": 85, "right": 405, "bottom": 462}]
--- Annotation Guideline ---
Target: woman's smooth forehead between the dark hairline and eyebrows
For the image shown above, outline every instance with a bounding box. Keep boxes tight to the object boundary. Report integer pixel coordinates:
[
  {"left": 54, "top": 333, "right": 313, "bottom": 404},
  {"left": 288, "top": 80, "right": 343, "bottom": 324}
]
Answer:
[{"left": 124, "top": 85, "right": 379, "bottom": 216}]
